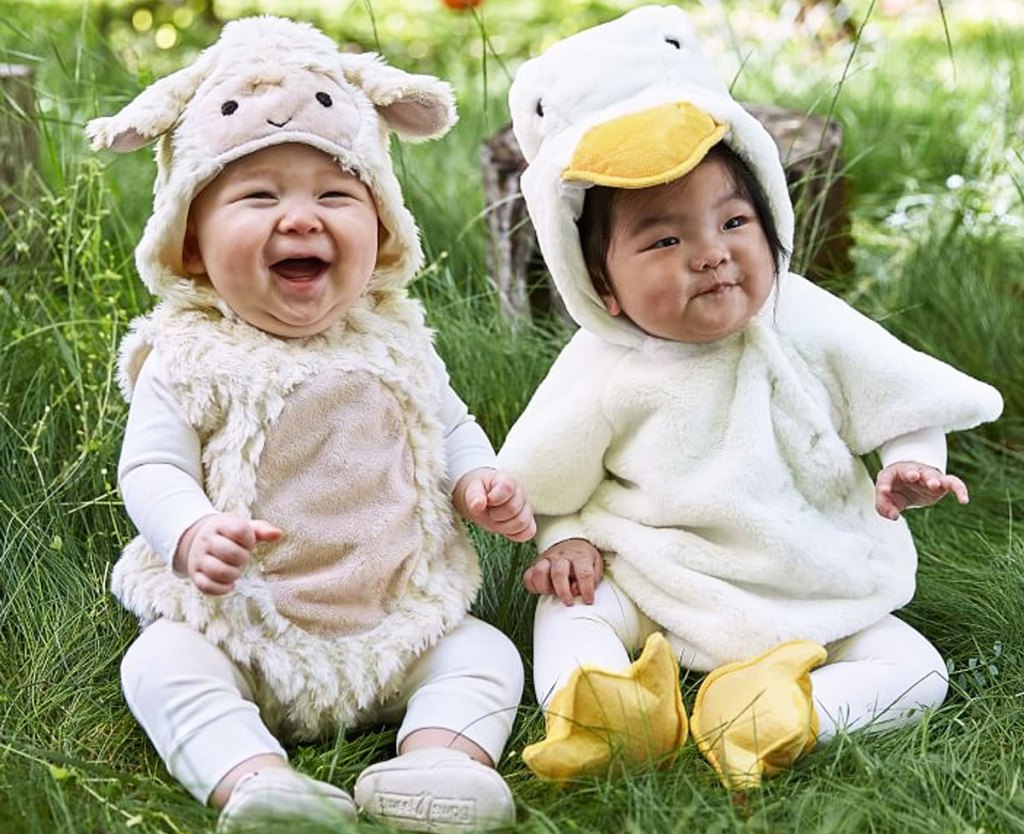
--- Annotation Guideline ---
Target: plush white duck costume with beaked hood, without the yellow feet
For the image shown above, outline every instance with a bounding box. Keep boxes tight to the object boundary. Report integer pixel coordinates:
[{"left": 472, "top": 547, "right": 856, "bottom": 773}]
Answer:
[{"left": 499, "top": 6, "right": 1001, "bottom": 790}]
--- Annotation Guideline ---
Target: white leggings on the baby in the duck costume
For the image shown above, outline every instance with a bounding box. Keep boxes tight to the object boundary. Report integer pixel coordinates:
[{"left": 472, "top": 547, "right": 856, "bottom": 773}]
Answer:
[{"left": 534, "top": 577, "right": 948, "bottom": 743}]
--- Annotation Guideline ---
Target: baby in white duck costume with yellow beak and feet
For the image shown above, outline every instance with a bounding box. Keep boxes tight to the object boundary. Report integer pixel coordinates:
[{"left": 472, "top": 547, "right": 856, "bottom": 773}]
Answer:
[{"left": 499, "top": 6, "right": 1002, "bottom": 787}]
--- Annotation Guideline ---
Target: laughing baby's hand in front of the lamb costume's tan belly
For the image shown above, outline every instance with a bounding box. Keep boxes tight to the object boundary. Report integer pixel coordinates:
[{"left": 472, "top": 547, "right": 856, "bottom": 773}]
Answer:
[{"left": 174, "top": 512, "right": 282, "bottom": 595}]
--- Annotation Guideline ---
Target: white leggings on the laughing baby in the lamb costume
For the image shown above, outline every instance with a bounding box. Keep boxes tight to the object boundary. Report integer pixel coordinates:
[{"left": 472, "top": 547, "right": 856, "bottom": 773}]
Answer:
[{"left": 121, "top": 617, "right": 523, "bottom": 802}]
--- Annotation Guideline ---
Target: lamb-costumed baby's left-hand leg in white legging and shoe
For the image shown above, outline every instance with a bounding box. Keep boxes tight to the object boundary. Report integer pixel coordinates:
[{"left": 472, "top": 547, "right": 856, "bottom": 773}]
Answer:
[{"left": 121, "top": 620, "right": 355, "bottom": 832}]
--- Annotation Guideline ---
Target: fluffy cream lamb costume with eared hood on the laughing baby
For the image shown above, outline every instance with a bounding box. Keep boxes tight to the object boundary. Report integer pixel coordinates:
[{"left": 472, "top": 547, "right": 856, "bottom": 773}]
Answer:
[{"left": 88, "top": 16, "right": 522, "bottom": 830}]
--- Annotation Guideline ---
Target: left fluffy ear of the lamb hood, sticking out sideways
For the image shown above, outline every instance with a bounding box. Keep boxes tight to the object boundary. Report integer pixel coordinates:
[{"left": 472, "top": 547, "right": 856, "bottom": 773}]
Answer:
[{"left": 85, "top": 57, "right": 209, "bottom": 154}]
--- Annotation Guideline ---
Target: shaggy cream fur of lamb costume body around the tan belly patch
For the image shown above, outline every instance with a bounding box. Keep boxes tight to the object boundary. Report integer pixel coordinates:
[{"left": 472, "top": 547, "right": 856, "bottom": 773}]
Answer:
[{"left": 111, "top": 298, "right": 480, "bottom": 739}]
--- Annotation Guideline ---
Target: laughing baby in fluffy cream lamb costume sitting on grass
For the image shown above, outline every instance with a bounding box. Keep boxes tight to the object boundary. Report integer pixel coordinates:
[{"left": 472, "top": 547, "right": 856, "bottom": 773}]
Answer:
[{"left": 89, "top": 16, "right": 534, "bottom": 831}]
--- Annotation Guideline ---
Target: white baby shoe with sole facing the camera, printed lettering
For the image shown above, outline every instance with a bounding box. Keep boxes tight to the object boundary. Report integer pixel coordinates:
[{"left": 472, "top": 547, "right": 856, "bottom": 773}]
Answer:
[{"left": 354, "top": 748, "right": 515, "bottom": 834}]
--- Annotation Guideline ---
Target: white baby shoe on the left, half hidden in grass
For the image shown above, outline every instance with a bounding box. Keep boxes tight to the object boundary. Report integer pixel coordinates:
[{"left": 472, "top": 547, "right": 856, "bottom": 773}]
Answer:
[{"left": 217, "top": 767, "right": 355, "bottom": 834}]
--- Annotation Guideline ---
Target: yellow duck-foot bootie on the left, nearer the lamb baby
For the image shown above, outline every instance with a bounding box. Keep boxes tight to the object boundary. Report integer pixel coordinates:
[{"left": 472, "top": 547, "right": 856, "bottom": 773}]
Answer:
[{"left": 522, "top": 633, "right": 687, "bottom": 782}]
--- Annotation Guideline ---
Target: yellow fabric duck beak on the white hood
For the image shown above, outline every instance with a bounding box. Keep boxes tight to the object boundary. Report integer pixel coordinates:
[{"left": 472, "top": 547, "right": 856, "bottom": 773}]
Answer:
[{"left": 562, "top": 101, "right": 728, "bottom": 189}]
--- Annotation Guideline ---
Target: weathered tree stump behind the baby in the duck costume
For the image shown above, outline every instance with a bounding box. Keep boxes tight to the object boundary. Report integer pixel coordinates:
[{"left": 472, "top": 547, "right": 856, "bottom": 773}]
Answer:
[{"left": 480, "top": 103, "right": 852, "bottom": 319}]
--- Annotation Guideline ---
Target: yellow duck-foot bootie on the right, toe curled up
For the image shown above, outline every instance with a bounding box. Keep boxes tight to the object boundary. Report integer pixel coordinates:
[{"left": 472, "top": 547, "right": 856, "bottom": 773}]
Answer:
[{"left": 690, "top": 640, "right": 827, "bottom": 789}]
